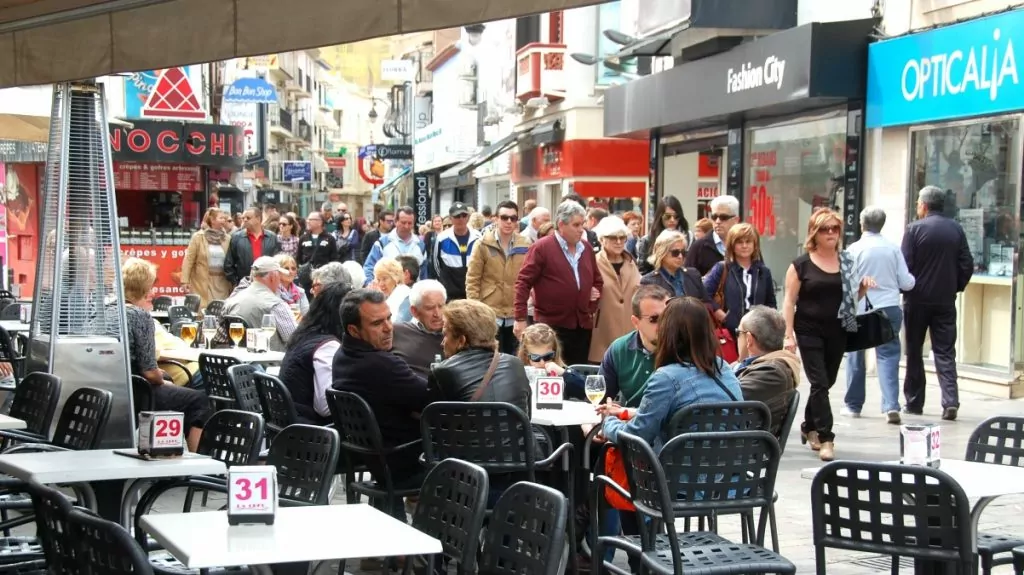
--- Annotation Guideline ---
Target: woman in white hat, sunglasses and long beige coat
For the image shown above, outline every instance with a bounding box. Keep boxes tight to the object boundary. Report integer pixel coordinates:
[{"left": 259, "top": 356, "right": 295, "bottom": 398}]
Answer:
[{"left": 588, "top": 216, "right": 640, "bottom": 363}]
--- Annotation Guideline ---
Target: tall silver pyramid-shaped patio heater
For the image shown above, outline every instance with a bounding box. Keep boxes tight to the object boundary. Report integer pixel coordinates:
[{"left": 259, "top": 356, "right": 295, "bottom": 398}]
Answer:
[{"left": 27, "top": 82, "right": 135, "bottom": 448}]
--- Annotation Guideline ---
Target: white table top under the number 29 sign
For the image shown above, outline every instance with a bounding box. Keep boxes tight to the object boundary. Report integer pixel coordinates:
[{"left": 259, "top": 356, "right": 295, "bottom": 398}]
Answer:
[{"left": 0, "top": 449, "right": 227, "bottom": 483}]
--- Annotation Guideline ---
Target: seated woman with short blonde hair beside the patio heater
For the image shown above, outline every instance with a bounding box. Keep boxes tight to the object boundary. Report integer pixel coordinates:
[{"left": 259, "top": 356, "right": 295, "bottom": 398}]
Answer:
[{"left": 115, "top": 258, "right": 211, "bottom": 451}]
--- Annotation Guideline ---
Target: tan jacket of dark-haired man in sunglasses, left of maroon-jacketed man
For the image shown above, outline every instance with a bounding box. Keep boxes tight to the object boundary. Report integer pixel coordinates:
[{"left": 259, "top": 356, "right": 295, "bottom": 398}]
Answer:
[{"left": 466, "top": 228, "right": 530, "bottom": 318}]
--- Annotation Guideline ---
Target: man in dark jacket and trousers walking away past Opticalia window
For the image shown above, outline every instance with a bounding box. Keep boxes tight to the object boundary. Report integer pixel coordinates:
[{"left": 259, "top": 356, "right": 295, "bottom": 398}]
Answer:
[{"left": 903, "top": 185, "right": 974, "bottom": 422}]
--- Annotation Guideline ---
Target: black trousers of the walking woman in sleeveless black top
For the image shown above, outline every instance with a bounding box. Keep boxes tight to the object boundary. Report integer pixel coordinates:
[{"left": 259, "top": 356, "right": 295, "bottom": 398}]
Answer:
[{"left": 797, "top": 331, "right": 846, "bottom": 441}]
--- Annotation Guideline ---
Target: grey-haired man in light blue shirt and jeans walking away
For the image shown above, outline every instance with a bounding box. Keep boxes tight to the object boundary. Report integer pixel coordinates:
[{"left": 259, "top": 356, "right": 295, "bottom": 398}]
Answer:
[{"left": 840, "top": 206, "right": 915, "bottom": 426}]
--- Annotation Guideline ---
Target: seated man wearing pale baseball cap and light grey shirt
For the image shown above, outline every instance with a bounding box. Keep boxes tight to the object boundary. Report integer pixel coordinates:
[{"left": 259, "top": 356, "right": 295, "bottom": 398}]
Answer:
[{"left": 224, "top": 256, "right": 295, "bottom": 351}]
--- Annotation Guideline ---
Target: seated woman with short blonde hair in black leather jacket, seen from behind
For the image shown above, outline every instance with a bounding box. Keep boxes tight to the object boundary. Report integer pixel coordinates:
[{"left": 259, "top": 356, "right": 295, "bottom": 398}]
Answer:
[{"left": 427, "top": 300, "right": 529, "bottom": 414}]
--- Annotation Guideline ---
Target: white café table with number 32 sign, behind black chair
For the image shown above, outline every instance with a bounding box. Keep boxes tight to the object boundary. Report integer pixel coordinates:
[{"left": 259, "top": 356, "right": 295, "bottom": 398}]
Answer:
[{"left": 800, "top": 459, "right": 1024, "bottom": 575}]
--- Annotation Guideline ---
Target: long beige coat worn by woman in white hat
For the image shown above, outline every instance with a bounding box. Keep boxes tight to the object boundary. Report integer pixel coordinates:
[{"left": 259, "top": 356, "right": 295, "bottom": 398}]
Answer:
[{"left": 589, "top": 250, "right": 640, "bottom": 363}]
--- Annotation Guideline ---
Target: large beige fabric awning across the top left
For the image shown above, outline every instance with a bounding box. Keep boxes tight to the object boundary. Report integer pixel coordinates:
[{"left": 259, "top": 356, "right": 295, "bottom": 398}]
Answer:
[{"left": 0, "top": 0, "right": 600, "bottom": 88}]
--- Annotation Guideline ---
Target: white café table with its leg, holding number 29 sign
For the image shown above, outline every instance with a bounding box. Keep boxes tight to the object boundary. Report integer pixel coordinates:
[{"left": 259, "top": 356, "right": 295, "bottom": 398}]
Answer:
[{"left": 0, "top": 448, "right": 227, "bottom": 523}]
